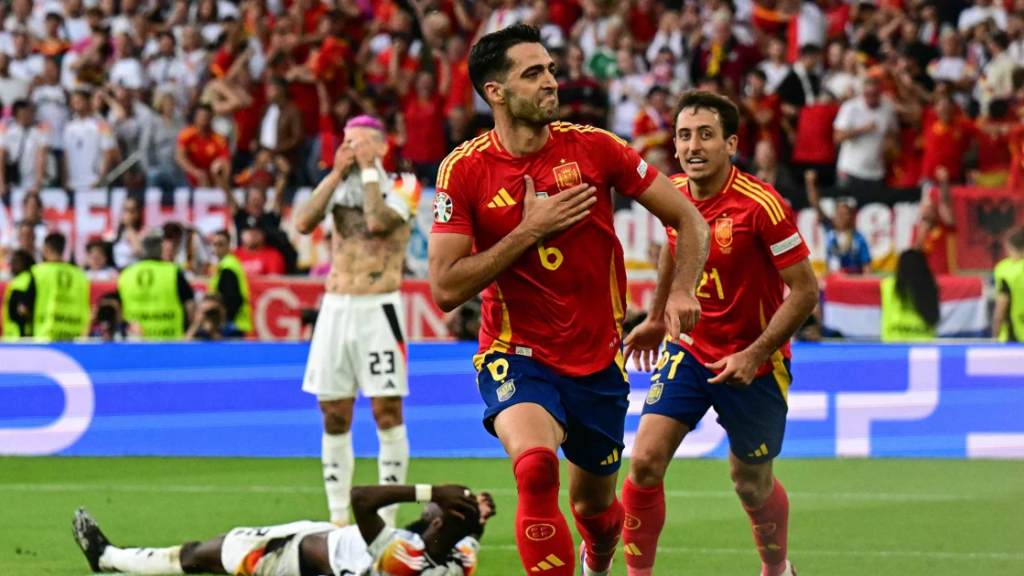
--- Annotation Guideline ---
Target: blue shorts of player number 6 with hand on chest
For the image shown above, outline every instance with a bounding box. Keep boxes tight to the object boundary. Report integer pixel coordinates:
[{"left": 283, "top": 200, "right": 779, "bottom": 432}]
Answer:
[{"left": 476, "top": 353, "right": 630, "bottom": 476}]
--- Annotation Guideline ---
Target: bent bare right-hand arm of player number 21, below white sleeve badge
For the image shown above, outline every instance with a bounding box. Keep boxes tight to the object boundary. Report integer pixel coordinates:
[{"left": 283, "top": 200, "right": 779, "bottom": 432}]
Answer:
[{"left": 706, "top": 258, "right": 818, "bottom": 386}]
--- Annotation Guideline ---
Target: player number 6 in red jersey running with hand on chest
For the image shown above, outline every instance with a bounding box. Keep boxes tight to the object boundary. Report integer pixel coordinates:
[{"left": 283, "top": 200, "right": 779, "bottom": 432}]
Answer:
[{"left": 429, "top": 25, "right": 709, "bottom": 576}]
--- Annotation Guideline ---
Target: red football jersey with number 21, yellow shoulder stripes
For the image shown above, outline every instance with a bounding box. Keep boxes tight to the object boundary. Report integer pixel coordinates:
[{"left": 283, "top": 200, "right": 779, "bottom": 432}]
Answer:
[{"left": 667, "top": 167, "right": 811, "bottom": 376}]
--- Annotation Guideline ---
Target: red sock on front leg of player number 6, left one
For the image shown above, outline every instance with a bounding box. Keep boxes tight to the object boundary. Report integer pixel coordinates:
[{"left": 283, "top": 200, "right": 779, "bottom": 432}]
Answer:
[{"left": 513, "top": 448, "right": 575, "bottom": 576}]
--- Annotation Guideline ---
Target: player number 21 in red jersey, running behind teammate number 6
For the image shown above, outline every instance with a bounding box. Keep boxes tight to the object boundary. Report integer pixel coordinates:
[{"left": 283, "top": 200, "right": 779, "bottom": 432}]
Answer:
[{"left": 623, "top": 91, "right": 817, "bottom": 576}]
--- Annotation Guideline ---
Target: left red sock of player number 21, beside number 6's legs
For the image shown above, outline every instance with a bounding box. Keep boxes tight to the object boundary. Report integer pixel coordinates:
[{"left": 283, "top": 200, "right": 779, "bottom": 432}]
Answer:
[{"left": 623, "top": 479, "right": 665, "bottom": 576}]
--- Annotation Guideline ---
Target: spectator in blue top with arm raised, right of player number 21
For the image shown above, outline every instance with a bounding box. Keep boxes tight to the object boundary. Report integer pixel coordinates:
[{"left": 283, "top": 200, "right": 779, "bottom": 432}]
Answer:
[{"left": 804, "top": 170, "right": 871, "bottom": 275}]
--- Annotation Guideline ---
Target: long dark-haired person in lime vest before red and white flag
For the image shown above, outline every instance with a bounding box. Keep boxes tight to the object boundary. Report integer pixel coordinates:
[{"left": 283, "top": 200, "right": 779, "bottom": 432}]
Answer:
[{"left": 881, "top": 250, "right": 939, "bottom": 342}]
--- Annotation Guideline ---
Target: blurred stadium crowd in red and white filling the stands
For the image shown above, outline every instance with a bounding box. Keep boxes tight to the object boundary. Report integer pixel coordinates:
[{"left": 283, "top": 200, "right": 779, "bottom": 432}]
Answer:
[{"left": 0, "top": 0, "right": 1024, "bottom": 338}]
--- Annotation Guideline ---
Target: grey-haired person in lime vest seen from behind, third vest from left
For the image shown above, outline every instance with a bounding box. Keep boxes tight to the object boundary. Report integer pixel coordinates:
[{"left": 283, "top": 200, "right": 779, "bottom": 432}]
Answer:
[{"left": 118, "top": 236, "right": 196, "bottom": 341}]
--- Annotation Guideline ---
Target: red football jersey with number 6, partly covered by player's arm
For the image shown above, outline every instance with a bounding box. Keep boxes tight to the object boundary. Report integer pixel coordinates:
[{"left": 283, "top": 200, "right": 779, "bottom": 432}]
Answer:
[{"left": 433, "top": 122, "right": 656, "bottom": 376}]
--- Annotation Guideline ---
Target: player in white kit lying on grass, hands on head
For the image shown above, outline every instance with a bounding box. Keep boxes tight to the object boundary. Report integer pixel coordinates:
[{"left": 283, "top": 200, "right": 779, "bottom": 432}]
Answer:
[{"left": 72, "top": 485, "right": 495, "bottom": 576}]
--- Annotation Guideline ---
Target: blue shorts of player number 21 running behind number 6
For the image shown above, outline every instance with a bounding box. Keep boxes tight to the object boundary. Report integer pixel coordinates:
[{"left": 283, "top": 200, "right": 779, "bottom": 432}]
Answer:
[{"left": 643, "top": 342, "right": 793, "bottom": 464}]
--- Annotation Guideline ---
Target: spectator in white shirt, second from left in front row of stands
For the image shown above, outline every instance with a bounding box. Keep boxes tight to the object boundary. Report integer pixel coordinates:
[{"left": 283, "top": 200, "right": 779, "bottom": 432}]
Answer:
[{"left": 63, "top": 90, "right": 117, "bottom": 191}]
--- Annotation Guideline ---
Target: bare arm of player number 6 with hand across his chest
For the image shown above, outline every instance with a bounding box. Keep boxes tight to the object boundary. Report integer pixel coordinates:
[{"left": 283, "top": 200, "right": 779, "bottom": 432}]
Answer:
[{"left": 428, "top": 176, "right": 597, "bottom": 312}]
